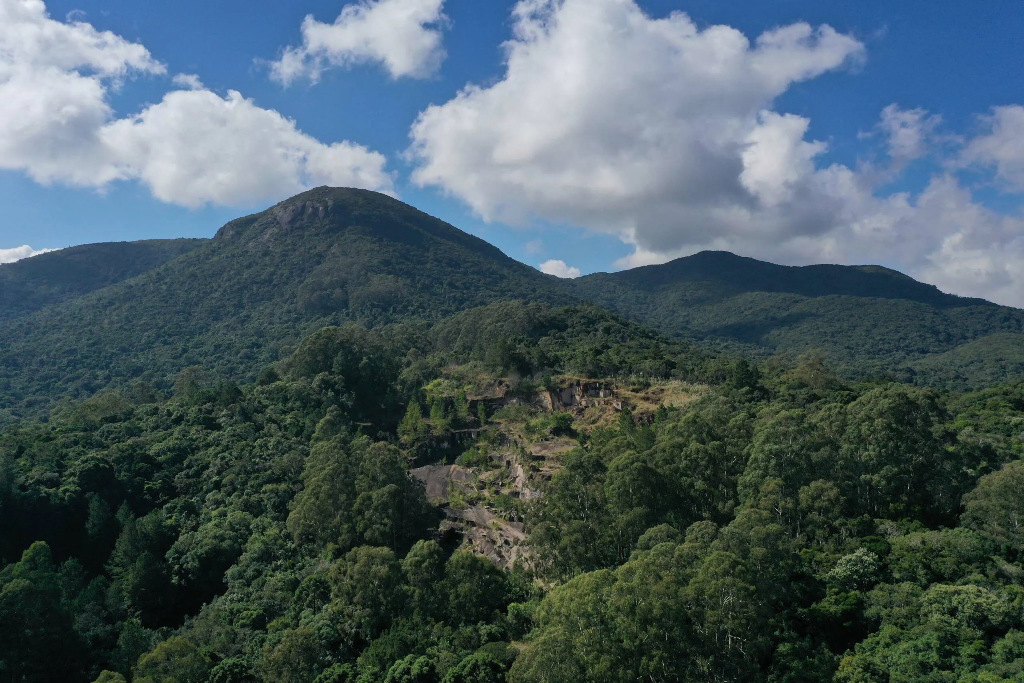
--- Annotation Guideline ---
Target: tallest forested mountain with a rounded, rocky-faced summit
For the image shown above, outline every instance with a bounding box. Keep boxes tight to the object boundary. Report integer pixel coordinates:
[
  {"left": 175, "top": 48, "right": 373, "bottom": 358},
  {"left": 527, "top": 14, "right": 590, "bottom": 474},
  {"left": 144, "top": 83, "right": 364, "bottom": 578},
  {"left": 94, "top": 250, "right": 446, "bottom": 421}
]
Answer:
[{"left": 0, "top": 187, "right": 570, "bottom": 422}]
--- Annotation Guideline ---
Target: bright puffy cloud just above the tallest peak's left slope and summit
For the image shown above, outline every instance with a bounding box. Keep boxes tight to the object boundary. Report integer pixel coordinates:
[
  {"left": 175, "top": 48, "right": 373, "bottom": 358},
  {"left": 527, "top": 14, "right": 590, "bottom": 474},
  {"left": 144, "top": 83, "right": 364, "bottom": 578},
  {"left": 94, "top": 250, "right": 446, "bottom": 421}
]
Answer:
[{"left": 100, "top": 90, "right": 390, "bottom": 207}]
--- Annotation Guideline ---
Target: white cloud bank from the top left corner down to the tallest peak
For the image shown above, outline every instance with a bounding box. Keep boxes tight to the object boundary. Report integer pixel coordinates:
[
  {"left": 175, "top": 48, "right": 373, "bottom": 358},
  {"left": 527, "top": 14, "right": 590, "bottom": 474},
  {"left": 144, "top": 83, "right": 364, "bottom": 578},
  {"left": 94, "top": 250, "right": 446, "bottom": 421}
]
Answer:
[{"left": 0, "top": 0, "right": 392, "bottom": 207}]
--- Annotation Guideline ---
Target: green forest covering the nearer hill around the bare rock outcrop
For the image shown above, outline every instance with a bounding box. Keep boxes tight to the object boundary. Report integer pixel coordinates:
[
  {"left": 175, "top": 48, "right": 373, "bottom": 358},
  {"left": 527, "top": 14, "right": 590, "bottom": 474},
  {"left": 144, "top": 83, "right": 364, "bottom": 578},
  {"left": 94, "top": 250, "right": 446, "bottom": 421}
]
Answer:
[{"left": 6, "top": 303, "right": 1024, "bottom": 683}]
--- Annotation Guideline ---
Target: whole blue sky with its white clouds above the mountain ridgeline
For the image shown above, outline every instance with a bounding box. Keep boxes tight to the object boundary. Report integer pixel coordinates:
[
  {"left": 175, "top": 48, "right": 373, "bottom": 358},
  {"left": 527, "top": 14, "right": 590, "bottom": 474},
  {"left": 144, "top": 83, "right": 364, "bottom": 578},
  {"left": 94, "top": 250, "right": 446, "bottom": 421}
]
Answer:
[{"left": 0, "top": 0, "right": 1024, "bottom": 305}]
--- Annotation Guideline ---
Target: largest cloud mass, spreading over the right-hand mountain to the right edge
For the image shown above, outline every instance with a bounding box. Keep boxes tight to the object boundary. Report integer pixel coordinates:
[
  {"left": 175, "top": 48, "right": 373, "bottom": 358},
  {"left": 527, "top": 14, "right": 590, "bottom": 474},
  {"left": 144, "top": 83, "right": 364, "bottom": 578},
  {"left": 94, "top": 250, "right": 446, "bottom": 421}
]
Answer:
[{"left": 410, "top": 0, "right": 1024, "bottom": 305}]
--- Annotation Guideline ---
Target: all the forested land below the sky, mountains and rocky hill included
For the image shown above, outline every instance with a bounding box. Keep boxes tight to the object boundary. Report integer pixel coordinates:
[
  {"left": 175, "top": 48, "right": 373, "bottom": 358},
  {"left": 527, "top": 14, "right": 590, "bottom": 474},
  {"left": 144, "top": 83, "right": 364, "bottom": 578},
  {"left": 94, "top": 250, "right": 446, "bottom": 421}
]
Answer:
[{"left": 6, "top": 188, "right": 1024, "bottom": 683}]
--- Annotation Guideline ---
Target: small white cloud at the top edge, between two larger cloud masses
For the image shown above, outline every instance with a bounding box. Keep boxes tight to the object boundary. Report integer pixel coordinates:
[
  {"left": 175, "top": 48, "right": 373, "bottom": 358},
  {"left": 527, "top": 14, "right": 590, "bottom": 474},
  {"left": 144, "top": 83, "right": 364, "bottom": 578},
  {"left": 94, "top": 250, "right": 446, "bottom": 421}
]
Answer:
[{"left": 270, "top": 0, "right": 447, "bottom": 85}]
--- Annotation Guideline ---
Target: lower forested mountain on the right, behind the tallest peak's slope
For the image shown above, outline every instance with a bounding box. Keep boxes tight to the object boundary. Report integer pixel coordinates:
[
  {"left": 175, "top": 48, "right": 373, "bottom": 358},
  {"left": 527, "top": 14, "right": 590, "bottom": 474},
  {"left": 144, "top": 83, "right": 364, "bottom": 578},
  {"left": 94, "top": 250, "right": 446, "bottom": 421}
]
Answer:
[{"left": 571, "top": 252, "right": 1024, "bottom": 388}]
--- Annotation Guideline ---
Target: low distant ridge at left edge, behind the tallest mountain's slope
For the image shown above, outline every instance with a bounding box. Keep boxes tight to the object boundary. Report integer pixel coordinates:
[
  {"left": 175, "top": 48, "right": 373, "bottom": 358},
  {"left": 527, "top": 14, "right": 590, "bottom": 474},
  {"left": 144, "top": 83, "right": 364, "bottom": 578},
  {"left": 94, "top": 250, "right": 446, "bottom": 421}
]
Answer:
[{"left": 0, "top": 240, "right": 204, "bottom": 319}]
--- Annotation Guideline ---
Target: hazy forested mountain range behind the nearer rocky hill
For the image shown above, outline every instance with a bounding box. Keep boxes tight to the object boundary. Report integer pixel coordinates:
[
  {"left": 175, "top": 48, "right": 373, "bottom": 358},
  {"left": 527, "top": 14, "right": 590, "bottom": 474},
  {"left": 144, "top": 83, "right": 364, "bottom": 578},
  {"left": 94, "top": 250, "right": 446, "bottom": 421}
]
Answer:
[{"left": 0, "top": 187, "right": 1024, "bottom": 424}]
